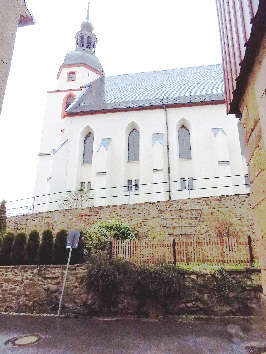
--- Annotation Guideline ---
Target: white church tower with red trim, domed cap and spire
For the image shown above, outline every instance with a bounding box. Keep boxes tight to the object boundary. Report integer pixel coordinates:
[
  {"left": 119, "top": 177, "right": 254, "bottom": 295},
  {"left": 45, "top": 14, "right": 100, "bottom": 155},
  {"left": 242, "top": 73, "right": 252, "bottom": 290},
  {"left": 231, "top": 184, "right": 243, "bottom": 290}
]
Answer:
[{"left": 35, "top": 4, "right": 104, "bottom": 211}]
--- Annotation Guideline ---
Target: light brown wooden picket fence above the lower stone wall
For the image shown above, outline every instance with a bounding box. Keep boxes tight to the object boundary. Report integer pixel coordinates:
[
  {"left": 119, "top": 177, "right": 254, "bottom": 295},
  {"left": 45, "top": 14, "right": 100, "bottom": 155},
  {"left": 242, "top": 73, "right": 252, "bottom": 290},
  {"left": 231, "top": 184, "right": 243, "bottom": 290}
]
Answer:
[{"left": 112, "top": 235, "right": 258, "bottom": 265}]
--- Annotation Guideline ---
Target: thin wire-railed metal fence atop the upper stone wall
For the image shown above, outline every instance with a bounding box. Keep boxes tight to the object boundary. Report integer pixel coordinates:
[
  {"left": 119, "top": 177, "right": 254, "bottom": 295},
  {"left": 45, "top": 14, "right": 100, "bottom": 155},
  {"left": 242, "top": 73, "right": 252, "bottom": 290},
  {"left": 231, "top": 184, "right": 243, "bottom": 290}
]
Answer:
[{"left": 6, "top": 174, "right": 249, "bottom": 216}]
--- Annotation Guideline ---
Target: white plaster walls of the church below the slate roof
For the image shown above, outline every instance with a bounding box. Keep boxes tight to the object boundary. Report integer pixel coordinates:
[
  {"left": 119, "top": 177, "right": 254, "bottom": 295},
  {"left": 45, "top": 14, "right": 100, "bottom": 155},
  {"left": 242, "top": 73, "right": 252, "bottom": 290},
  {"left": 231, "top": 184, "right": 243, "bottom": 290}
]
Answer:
[{"left": 34, "top": 101, "right": 249, "bottom": 210}]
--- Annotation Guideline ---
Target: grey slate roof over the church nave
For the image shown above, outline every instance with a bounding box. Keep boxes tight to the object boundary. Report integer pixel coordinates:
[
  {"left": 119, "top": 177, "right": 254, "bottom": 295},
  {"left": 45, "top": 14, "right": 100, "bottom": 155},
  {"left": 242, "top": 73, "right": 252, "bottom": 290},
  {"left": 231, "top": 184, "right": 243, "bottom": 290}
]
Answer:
[{"left": 67, "top": 65, "right": 224, "bottom": 114}]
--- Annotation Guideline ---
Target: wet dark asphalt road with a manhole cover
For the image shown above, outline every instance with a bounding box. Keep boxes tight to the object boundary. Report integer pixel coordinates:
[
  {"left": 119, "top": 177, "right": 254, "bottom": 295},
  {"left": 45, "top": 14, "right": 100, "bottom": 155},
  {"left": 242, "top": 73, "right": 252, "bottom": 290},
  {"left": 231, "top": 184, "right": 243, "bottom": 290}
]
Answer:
[{"left": 0, "top": 315, "right": 266, "bottom": 354}]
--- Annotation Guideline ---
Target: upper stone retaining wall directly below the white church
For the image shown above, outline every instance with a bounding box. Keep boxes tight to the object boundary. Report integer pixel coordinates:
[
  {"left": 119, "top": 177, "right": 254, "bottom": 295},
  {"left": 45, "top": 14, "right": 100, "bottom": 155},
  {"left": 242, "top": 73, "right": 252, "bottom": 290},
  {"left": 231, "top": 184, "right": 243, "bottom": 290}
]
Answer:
[{"left": 7, "top": 195, "right": 254, "bottom": 237}]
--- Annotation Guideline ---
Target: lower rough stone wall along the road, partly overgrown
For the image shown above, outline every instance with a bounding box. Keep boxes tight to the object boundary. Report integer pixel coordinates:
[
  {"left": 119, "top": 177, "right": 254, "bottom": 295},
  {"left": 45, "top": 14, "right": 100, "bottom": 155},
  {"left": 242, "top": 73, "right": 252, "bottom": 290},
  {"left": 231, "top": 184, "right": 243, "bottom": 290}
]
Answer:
[{"left": 0, "top": 265, "right": 261, "bottom": 317}]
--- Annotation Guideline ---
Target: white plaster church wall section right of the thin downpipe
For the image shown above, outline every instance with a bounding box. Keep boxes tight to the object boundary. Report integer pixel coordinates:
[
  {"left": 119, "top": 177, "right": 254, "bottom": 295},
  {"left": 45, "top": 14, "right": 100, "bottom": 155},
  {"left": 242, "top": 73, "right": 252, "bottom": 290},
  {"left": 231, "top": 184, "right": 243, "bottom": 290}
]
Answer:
[{"left": 167, "top": 104, "right": 248, "bottom": 199}]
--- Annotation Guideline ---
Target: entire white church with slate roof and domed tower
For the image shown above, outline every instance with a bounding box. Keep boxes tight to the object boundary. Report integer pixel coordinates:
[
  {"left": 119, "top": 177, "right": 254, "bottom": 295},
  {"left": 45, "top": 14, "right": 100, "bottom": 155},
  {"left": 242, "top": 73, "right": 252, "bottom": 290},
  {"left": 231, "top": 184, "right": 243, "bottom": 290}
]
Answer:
[{"left": 34, "top": 9, "right": 249, "bottom": 211}]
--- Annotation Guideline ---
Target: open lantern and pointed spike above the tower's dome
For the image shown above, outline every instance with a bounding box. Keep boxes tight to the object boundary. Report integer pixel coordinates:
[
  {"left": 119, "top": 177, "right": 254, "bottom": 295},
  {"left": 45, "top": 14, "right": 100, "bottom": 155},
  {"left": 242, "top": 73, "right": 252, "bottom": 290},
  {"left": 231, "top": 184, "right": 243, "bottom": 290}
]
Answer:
[{"left": 75, "top": 2, "right": 97, "bottom": 54}]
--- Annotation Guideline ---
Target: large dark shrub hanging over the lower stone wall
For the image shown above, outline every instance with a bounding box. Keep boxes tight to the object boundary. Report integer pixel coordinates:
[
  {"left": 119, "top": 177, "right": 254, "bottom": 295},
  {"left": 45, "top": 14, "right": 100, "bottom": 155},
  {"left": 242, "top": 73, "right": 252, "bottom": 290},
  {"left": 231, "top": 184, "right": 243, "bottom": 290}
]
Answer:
[{"left": 86, "top": 253, "right": 186, "bottom": 309}]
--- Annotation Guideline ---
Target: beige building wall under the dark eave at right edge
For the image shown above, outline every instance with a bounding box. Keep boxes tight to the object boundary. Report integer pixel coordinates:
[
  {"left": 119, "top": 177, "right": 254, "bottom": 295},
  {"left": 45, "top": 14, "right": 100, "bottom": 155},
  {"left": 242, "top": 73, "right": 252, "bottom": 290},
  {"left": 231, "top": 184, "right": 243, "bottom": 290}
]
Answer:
[{"left": 240, "top": 37, "right": 266, "bottom": 296}]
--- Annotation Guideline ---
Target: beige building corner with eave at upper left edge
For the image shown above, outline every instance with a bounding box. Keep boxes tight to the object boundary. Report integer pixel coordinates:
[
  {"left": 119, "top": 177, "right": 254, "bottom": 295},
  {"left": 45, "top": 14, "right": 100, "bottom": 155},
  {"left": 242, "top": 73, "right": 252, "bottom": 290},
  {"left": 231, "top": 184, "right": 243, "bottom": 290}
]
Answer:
[{"left": 0, "top": 0, "right": 34, "bottom": 113}]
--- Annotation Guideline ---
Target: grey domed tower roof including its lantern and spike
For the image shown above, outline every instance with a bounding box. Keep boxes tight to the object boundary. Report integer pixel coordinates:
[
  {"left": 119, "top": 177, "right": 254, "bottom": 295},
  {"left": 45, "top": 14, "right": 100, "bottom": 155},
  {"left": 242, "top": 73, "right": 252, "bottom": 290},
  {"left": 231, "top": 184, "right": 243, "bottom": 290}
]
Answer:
[{"left": 63, "top": 3, "right": 104, "bottom": 74}]
